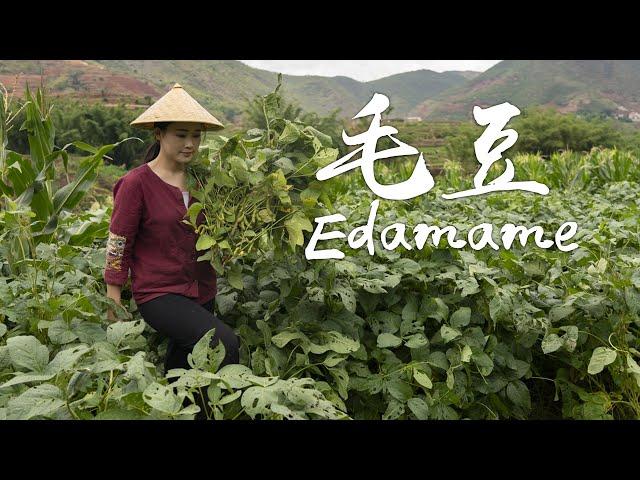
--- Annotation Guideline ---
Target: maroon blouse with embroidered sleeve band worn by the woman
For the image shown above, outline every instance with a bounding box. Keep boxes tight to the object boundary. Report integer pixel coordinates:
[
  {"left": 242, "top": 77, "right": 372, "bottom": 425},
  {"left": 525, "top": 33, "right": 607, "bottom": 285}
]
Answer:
[{"left": 104, "top": 163, "right": 217, "bottom": 305}]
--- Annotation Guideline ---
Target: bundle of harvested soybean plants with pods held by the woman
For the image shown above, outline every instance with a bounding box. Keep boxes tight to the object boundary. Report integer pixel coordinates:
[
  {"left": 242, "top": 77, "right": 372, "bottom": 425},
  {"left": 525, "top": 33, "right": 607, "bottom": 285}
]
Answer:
[{"left": 184, "top": 86, "right": 338, "bottom": 285}]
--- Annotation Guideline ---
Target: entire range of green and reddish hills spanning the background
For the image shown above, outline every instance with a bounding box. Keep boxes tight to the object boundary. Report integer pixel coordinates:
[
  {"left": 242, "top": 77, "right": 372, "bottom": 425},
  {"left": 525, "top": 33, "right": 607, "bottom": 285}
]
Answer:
[{"left": 0, "top": 60, "right": 640, "bottom": 123}]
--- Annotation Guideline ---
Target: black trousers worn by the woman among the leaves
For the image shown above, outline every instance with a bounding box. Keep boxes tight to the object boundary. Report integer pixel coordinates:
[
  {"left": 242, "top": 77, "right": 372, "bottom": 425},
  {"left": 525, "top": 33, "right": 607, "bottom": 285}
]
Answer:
[{"left": 138, "top": 293, "right": 240, "bottom": 374}]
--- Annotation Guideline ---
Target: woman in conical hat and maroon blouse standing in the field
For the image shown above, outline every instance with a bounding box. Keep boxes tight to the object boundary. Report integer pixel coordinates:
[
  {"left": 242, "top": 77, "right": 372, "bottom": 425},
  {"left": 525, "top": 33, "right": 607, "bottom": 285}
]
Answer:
[{"left": 104, "top": 84, "right": 239, "bottom": 416}]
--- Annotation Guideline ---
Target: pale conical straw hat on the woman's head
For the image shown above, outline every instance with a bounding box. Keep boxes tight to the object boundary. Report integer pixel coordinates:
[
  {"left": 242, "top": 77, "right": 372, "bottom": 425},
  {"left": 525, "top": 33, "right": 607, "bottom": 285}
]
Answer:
[{"left": 131, "top": 83, "right": 224, "bottom": 130}]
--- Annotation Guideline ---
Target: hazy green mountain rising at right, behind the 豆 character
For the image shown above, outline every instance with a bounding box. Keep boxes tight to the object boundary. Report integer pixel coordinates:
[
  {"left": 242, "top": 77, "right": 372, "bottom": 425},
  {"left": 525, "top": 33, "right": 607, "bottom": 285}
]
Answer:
[{"left": 410, "top": 60, "right": 640, "bottom": 120}]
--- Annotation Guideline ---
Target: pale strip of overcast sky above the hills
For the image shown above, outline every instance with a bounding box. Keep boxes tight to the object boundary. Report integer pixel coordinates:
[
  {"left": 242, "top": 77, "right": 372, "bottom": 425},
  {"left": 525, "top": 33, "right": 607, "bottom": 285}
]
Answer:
[{"left": 240, "top": 60, "right": 500, "bottom": 82}]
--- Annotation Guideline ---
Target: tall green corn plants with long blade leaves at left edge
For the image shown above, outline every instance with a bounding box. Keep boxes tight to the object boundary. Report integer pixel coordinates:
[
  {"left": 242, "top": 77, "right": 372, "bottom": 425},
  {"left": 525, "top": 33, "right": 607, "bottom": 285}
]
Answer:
[{"left": 0, "top": 89, "right": 134, "bottom": 273}]
